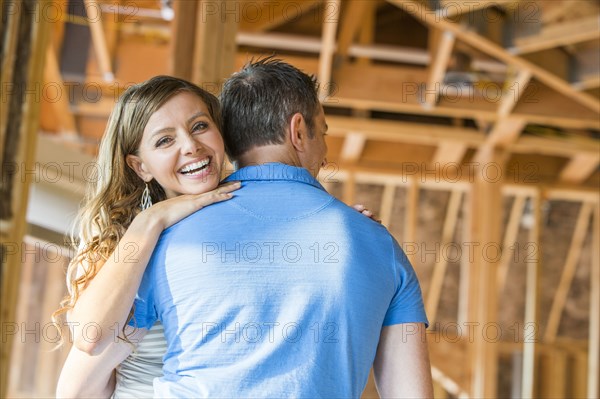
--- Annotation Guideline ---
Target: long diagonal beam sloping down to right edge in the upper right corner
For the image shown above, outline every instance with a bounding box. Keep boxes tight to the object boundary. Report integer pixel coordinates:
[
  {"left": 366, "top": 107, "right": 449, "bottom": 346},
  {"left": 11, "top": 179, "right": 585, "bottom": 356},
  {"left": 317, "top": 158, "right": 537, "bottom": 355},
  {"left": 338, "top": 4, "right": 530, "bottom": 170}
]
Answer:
[{"left": 389, "top": 0, "right": 600, "bottom": 113}]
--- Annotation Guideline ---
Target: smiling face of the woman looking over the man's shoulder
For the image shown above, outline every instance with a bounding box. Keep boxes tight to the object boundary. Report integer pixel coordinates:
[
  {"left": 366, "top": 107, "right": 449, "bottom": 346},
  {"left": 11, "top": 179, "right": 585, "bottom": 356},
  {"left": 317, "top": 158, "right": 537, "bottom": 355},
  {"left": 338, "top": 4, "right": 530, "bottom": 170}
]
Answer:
[{"left": 127, "top": 91, "right": 225, "bottom": 198}]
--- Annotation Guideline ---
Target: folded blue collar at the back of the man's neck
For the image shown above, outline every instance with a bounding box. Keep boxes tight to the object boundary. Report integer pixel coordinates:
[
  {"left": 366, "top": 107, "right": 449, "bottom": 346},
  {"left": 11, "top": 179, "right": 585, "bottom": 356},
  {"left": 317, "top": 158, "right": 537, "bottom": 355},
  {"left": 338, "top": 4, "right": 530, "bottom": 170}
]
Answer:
[{"left": 224, "top": 162, "right": 326, "bottom": 191}]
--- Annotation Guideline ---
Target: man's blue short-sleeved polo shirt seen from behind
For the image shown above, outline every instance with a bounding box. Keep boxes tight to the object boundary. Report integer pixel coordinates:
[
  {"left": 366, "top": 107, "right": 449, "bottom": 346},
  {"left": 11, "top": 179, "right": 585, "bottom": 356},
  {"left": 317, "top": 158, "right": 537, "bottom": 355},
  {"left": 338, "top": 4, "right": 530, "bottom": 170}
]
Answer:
[{"left": 135, "top": 163, "right": 427, "bottom": 398}]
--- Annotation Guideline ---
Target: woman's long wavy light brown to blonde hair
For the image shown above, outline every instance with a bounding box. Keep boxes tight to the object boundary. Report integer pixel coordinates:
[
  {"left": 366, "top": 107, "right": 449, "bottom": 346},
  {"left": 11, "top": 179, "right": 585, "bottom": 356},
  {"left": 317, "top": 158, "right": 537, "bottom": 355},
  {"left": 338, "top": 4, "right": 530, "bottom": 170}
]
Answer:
[{"left": 52, "top": 76, "right": 221, "bottom": 340}]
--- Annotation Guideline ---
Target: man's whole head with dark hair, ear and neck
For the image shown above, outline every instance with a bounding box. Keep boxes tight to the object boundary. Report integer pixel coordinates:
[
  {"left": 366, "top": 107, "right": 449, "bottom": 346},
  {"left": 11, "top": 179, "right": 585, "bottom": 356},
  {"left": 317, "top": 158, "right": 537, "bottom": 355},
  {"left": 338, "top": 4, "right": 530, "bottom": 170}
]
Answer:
[{"left": 221, "top": 57, "right": 327, "bottom": 175}]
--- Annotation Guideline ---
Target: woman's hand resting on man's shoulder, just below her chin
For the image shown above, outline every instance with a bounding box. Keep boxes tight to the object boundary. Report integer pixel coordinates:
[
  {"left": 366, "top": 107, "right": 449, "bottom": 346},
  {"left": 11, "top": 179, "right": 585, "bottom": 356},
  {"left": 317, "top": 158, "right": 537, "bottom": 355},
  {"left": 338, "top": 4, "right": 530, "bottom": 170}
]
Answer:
[{"left": 135, "top": 182, "right": 242, "bottom": 231}]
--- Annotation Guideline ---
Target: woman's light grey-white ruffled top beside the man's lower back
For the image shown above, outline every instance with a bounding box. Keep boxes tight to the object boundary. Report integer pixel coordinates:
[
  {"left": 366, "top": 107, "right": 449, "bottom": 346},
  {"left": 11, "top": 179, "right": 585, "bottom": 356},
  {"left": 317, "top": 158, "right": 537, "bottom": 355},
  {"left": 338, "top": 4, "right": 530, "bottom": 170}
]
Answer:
[{"left": 112, "top": 322, "right": 167, "bottom": 399}]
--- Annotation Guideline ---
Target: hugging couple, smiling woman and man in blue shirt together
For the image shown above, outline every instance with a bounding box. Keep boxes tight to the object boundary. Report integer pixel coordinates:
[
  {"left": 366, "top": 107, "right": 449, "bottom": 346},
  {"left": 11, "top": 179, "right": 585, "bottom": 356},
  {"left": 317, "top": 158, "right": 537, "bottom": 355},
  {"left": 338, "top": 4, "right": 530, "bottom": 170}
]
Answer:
[{"left": 55, "top": 57, "right": 432, "bottom": 398}]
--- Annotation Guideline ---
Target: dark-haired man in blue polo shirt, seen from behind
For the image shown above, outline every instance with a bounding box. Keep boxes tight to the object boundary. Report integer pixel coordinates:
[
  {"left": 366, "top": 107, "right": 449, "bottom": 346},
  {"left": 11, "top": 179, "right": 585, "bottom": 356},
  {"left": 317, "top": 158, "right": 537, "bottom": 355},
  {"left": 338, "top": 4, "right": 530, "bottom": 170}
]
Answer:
[{"left": 57, "top": 58, "right": 433, "bottom": 398}]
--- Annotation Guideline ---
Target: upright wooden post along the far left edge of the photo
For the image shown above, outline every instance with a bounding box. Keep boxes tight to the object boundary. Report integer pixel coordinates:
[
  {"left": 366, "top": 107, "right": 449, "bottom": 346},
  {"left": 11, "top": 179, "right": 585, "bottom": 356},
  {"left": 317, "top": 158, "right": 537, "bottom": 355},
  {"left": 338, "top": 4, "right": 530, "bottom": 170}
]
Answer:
[{"left": 0, "top": 0, "right": 50, "bottom": 398}]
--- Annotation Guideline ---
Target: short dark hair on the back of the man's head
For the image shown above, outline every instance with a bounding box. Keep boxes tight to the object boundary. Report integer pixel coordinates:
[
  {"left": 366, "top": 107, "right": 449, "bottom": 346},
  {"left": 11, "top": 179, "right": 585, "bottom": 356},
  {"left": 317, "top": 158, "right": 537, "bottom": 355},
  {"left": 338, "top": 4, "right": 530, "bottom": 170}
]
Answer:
[{"left": 221, "top": 56, "right": 319, "bottom": 160}]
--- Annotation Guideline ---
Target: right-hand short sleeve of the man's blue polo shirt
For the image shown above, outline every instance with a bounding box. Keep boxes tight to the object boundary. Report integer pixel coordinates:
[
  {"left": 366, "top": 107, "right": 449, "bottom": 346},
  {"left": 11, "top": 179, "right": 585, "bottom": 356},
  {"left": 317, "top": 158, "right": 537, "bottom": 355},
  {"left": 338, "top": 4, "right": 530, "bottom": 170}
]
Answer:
[{"left": 383, "top": 237, "right": 429, "bottom": 326}]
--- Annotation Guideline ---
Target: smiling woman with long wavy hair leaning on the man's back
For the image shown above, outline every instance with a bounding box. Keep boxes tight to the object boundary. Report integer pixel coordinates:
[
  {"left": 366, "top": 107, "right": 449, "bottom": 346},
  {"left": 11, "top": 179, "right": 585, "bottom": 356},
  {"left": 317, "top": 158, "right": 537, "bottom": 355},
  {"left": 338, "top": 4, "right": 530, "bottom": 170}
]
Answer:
[{"left": 55, "top": 76, "right": 240, "bottom": 397}]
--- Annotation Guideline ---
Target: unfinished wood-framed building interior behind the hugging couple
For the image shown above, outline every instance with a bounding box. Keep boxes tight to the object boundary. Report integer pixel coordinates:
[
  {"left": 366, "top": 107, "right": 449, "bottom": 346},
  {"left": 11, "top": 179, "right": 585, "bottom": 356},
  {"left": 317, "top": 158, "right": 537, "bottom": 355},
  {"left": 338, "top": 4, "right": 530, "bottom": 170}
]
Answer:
[{"left": 0, "top": 0, "right": 600, "bottom": 398}]
